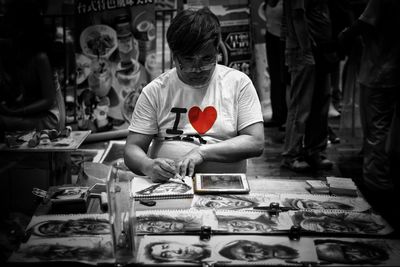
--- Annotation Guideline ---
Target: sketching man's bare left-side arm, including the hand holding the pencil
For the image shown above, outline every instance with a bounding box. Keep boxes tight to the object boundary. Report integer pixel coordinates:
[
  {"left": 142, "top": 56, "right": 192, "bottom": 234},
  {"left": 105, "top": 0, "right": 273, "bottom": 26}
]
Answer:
[{"left": 124, "top": 132, "right": 175, "bottom": 181}]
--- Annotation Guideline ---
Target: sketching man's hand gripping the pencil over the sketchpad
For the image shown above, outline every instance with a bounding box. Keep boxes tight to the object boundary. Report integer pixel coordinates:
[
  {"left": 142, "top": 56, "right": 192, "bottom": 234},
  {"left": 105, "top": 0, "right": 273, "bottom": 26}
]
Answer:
[{"left": 144, "top": 158, "right": 176, "bottom": 182}]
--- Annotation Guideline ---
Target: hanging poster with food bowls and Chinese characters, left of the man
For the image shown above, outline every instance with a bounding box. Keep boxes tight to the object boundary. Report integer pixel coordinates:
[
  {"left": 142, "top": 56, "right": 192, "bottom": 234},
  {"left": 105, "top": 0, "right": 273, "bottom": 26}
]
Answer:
[{"left": 75, "top": 0, "right": 156, "bottom": 133}]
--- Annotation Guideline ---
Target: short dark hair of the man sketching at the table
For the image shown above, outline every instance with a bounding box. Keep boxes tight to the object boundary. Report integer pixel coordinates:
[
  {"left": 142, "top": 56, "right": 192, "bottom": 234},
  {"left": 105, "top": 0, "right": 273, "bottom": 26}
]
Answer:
[{"left": 167, "top": 7, "right": 221, "bottom": 56}]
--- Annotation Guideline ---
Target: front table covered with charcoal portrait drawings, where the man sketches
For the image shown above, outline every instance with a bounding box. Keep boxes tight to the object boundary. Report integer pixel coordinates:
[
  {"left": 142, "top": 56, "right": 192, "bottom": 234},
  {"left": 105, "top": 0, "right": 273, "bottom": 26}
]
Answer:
[{"left": 10, "top": 168, "right": 400, "bottom": 266}]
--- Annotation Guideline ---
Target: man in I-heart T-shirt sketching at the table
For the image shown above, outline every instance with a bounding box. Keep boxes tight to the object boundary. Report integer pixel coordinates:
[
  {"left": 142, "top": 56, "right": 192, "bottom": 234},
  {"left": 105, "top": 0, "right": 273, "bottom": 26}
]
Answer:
[{"left": 125, "top": 8, "right": 264, "bottom": 181}]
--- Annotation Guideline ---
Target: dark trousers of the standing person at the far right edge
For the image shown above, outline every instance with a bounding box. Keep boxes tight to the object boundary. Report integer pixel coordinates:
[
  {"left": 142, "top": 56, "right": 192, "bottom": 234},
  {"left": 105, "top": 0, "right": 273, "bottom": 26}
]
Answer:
[{"left": 360, "top": 85, "right": 400, "bottom": 225}]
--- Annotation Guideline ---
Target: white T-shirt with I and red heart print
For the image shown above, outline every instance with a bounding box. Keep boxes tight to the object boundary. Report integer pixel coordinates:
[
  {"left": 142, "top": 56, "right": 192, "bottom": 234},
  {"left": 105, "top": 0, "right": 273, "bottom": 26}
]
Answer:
[{"left": 128, "top": 65, "right": 263, "bottom": 174}]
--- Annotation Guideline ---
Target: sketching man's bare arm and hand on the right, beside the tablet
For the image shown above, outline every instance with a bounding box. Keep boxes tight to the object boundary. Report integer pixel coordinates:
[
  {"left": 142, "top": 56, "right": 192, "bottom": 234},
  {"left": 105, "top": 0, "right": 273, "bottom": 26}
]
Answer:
[{"left": 177, "top": 122, "right": 264, "bottom": 176}]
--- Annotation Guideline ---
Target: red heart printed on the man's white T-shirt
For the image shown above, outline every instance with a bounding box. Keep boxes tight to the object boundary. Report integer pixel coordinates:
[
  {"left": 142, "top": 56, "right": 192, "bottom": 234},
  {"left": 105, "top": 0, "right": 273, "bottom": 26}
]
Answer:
[{"left": 189, "top": 106, "right": 217, "bottom": 134}]
